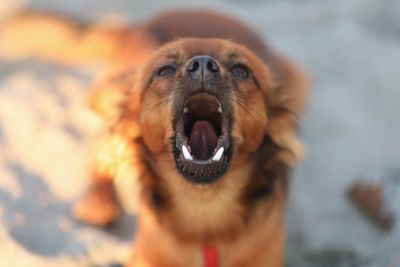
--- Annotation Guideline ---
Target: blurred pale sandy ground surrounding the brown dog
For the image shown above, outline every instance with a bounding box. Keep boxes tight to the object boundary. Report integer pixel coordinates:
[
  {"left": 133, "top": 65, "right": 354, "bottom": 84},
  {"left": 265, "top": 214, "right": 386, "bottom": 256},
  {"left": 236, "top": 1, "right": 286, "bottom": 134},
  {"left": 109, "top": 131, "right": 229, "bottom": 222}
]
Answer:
[{"left": 0, "top": 0, "right": 400, "bottom": 267}]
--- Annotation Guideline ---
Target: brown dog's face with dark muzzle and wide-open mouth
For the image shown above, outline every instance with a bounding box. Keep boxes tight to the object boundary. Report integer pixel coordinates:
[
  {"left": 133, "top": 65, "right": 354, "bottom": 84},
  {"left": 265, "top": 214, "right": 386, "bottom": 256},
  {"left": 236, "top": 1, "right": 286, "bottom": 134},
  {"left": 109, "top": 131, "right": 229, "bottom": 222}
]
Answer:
[{"left": 140, "top": 39, "right": 270, "bottom": 184}]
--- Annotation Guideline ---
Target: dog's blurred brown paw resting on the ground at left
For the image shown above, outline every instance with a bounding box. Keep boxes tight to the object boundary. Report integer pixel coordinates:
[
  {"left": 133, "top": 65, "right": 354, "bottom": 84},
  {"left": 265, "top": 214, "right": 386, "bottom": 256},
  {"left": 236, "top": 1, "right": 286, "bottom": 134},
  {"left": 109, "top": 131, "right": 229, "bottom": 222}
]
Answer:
[{"left": 73, "top": 180, "right": 120, "bottom": 227}]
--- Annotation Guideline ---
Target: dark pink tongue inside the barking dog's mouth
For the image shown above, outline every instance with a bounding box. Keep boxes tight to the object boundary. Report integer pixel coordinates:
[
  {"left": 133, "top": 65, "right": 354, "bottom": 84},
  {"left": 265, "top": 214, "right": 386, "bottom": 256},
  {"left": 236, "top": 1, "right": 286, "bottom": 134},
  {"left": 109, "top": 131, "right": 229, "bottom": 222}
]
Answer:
[{"left": 188, "top": 120, "right": 218, "bottom": 160}]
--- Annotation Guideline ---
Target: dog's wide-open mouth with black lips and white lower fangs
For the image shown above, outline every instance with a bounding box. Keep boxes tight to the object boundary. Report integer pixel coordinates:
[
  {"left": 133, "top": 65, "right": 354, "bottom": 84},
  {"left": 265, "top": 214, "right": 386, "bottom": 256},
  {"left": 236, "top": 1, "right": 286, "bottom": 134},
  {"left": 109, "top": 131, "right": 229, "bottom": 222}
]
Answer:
[{"left": 174, "top": 93, "right": 232, "bottom": 184}]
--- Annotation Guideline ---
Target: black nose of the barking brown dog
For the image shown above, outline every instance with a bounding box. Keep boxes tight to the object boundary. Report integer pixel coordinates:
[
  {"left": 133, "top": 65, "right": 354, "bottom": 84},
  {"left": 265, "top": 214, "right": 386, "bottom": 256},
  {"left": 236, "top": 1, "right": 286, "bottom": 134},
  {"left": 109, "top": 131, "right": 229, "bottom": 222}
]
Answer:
[{"left": 186, "top": 56, "right": 219, "bottom": 81}]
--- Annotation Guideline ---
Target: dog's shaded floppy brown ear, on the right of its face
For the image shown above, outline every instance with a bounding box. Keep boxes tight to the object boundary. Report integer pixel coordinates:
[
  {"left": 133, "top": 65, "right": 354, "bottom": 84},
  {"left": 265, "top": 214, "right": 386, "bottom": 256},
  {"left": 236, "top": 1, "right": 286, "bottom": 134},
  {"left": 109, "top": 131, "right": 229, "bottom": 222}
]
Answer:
[{"left": 266, "top": 56, "right": 309, "bottom": 165}]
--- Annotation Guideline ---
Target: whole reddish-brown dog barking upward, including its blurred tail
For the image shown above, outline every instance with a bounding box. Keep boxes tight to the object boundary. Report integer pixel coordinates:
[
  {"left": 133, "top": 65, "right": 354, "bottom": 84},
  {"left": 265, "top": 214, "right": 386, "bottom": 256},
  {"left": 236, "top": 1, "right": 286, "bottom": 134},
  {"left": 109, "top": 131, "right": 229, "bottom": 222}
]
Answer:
[{"left": 0, "top": 11, "right": 308, "bottom": 267}]
